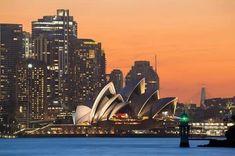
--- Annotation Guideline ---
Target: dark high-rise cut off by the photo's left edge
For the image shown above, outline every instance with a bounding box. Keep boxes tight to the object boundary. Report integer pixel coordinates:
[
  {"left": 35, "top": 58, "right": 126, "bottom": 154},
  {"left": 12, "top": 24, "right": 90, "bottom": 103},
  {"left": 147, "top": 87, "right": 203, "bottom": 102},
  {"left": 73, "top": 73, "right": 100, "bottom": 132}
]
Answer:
[{"left": 0, "top": 24, "right": 23, "bottom": 133}]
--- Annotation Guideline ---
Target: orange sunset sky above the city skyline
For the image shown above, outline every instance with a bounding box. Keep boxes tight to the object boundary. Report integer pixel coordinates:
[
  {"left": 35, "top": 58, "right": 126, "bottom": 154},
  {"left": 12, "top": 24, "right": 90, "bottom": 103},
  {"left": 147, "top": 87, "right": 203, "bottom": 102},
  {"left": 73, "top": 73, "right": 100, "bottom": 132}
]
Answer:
[{"left": 0, "top": 0, "right": 235, "bottom": 105}]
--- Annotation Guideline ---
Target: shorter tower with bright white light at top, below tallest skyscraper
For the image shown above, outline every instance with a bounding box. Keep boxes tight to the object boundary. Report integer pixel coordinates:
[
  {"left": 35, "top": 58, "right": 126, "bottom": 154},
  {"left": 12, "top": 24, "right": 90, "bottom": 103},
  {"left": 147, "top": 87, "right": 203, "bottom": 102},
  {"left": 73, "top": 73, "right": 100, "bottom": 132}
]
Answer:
[{"left": 17, "top": 59, "right": 47, "bottom": 128}]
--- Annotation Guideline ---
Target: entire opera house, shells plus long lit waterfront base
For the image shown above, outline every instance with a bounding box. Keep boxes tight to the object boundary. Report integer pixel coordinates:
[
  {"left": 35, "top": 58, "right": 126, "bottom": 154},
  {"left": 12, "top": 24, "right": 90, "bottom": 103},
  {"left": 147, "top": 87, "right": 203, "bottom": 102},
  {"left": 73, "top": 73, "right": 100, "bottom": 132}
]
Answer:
[{"left": 17, "top": 78, "right": 177, "bottom": 135}]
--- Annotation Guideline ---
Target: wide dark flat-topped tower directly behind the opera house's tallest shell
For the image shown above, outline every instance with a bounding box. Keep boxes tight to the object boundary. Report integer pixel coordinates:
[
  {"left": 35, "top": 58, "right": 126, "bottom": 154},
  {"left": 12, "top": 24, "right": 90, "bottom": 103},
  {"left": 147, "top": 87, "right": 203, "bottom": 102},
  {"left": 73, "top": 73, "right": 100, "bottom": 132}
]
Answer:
[{"left": 126, "top": 61, "right": 159, "bottom": 92}]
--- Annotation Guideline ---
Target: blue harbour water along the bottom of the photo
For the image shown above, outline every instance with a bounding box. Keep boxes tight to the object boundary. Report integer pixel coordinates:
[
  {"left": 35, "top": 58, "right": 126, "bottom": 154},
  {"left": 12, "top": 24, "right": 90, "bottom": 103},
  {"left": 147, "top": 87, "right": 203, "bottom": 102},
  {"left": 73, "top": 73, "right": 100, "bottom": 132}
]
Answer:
[{"left": 0, "top": 138, "right": 235, "bottom": 156}]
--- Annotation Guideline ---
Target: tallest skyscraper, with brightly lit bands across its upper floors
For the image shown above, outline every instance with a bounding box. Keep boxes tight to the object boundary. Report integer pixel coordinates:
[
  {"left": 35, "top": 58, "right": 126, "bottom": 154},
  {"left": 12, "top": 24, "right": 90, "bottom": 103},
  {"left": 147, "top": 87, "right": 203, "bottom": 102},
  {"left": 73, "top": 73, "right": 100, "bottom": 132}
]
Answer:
[{"left": 32, "top": 9, "right": 77, "bottom": 117}]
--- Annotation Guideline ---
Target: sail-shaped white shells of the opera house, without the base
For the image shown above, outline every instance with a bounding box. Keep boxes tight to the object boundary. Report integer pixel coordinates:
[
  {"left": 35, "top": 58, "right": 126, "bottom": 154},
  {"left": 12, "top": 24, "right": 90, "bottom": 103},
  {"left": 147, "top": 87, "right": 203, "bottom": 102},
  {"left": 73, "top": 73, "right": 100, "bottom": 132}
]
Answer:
[{"left": 73, "top": 78, "right": 177, "bottom": 125}]
